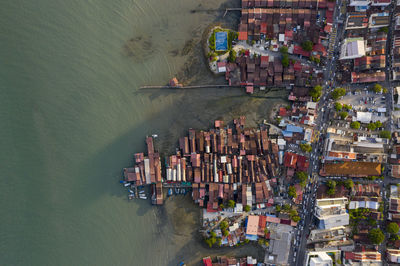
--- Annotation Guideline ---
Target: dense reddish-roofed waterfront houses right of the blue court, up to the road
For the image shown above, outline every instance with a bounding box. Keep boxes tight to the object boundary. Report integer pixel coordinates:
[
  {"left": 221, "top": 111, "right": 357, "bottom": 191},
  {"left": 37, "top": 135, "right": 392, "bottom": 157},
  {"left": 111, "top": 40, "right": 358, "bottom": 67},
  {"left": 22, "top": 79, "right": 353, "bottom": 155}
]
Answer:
[{"left": 218, "top": 0, "right": 335, "bottom": 95}]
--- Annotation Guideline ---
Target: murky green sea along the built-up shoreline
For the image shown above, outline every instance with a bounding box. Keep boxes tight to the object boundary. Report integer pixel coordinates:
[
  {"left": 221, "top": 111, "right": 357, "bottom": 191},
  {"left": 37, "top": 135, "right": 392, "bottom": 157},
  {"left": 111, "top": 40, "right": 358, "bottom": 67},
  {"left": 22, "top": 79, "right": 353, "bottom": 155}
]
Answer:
[{"left": 0, "top": 0, "right": 285, "bottom": 265}]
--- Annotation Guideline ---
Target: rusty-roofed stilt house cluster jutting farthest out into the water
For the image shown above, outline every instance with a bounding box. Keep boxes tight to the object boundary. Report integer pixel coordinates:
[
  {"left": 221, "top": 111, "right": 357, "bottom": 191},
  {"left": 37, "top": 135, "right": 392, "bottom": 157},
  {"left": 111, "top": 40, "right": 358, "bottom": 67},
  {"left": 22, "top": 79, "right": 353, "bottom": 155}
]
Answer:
[{"left": 124, "top": 117, "right": 282, "bottom": 212}]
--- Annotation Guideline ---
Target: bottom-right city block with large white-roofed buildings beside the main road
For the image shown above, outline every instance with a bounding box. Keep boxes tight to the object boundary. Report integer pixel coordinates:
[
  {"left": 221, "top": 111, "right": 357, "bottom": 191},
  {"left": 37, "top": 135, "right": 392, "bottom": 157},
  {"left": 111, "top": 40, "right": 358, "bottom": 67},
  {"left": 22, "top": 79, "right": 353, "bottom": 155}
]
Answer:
[{"left": 305, "top": 183, "right": 383, "bottom": 265}]
